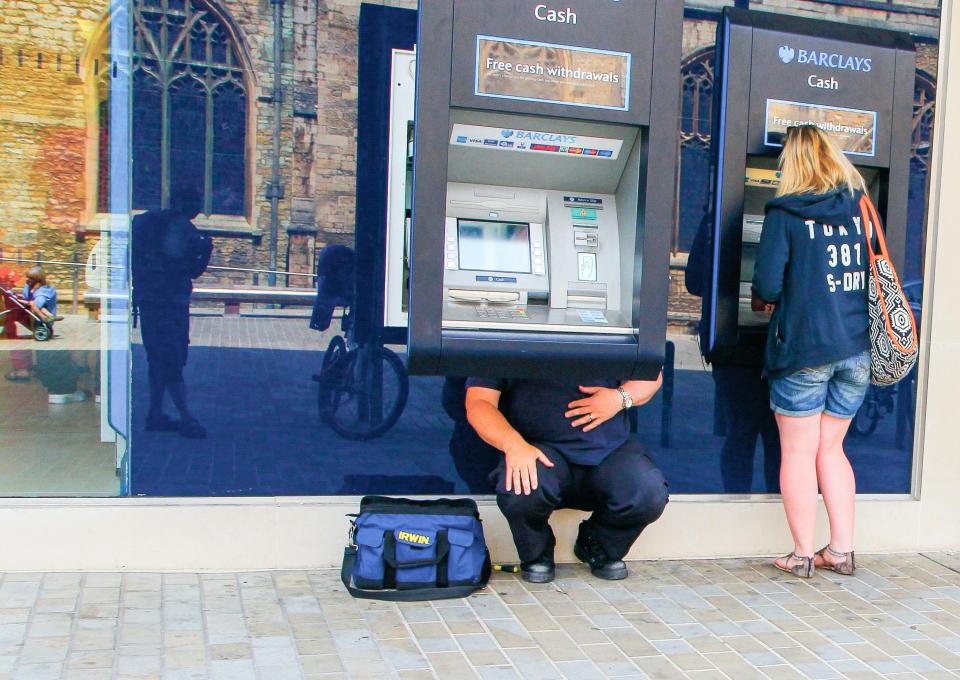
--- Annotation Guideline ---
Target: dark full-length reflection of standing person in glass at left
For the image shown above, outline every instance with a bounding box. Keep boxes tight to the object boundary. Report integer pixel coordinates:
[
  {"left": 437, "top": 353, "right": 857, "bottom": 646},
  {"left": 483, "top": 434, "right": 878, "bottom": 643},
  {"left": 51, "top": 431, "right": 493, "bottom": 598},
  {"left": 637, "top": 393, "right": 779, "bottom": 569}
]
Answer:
[{"left": 131, "top": 188, "right": 213, "bottom": 439}]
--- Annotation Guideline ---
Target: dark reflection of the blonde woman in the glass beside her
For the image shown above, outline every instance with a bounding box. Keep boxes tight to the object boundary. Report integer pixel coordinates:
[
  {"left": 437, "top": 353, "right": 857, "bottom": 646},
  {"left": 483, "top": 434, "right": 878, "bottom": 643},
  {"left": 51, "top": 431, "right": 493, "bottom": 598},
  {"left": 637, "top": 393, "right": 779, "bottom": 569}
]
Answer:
[{"left": 685, "top": 213, "right": 780, "bottom": 493}]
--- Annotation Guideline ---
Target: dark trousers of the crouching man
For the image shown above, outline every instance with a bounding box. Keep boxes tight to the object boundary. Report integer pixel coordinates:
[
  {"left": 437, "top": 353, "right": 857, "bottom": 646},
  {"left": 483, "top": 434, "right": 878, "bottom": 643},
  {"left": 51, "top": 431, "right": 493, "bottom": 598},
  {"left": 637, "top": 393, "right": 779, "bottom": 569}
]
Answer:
[{"left": 496, "top": 439, "right": 668, "bottom": 562}]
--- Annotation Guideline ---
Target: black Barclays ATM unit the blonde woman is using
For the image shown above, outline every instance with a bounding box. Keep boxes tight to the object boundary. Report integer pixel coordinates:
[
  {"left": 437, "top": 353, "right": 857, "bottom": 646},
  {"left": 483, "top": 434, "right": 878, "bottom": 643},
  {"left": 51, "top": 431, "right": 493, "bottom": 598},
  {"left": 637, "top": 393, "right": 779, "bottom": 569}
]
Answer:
[{"left": 701, "top": 7, "right": 916, "bottom": 361}]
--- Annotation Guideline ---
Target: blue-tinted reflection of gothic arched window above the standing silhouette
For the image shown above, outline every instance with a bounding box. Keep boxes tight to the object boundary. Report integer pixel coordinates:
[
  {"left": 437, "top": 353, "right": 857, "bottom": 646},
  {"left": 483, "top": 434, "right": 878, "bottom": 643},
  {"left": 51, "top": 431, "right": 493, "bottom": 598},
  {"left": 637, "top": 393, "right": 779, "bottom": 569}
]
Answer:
[{"left": 132, "top": 0, "right": 248, "bottom": 215}]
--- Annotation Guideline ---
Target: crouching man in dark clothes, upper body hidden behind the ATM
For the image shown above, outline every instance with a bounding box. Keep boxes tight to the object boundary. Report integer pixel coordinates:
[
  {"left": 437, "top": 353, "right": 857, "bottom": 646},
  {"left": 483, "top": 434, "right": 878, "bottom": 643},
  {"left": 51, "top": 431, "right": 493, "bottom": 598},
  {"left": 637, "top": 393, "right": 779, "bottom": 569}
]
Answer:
[{"left": 466, "top": 377, "right": 668, "bottom": 583}]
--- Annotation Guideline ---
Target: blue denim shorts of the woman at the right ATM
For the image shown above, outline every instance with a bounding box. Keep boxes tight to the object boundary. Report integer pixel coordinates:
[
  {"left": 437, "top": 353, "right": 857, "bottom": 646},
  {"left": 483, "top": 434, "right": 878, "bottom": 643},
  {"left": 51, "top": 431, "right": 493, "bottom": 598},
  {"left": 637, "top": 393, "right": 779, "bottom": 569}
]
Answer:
[{"left": 770, "top": 351, "right": 870, "bottom": 418}]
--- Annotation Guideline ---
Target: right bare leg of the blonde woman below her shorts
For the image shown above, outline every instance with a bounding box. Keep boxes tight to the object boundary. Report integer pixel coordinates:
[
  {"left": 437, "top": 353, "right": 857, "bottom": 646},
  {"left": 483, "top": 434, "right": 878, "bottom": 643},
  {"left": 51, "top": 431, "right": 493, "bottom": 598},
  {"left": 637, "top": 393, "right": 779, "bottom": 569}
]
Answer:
[{"left": 817, "top": 414, "right": 857, "bottom": 553}]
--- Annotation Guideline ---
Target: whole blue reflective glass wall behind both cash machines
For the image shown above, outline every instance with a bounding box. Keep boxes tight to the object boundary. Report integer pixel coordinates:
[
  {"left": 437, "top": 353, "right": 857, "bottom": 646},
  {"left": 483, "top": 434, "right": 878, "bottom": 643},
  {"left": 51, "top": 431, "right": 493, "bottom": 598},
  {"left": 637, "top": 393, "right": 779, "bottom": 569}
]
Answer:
[{"left": 125, "top": 0, "right": 939, "bottom": 496}]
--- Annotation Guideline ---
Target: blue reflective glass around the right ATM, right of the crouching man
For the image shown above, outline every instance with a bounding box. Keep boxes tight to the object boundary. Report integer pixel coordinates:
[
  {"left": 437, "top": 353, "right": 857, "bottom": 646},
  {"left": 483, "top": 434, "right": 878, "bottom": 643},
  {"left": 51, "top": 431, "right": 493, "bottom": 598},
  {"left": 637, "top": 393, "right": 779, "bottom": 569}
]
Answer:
[{"left": 656, "top": 0, "right": 939, "bottom": 494}]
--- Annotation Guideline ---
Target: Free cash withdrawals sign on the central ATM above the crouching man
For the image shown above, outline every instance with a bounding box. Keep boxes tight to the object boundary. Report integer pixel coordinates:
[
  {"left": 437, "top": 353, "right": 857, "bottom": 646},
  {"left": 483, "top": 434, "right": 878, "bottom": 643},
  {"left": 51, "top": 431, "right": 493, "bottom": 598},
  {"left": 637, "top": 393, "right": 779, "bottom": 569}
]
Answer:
[{"left": 475, "top": 35, "right": 631, "bottom": 111}]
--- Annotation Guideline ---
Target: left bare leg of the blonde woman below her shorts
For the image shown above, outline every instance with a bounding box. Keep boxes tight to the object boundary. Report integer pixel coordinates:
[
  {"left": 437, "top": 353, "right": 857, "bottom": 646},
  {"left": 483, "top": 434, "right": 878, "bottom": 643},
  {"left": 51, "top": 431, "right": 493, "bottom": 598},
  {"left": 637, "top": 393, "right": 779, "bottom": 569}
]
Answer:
[{"left": 777, "top": 413, "right": 820, "bottom": 557}]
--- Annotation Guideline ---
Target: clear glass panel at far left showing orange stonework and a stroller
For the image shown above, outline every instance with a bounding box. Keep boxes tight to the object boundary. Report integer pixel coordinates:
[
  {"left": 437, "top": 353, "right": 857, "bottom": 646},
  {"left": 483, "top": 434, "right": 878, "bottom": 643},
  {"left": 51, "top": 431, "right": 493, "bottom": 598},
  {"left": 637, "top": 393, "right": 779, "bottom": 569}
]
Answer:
[{"left": 0, "top": 0, "right": 130, "bottom": 496}]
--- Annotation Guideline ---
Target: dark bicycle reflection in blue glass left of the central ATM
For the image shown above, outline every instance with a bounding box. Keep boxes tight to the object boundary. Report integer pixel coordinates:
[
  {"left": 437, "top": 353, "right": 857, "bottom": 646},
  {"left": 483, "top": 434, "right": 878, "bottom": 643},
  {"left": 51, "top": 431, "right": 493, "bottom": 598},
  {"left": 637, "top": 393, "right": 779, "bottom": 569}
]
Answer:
[{"left": 310, "top": 245, "right": 410, "bottom": 441}]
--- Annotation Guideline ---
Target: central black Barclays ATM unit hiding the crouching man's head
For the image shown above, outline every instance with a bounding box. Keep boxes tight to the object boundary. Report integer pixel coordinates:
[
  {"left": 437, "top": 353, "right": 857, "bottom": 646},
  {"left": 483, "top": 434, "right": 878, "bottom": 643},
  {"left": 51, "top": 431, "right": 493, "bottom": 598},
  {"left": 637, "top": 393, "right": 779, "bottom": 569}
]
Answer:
[{"left": 408, "top": 0, "right": 683, "bottom": 378}]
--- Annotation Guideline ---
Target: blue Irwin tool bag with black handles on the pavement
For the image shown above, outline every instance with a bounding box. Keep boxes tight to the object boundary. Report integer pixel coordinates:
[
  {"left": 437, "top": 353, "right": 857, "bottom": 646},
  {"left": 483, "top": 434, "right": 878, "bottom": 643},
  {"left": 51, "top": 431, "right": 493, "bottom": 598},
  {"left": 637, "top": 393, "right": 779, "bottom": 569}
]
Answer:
[{"left": 340, "top": 496, "right": 490, "bottom": 602}]
